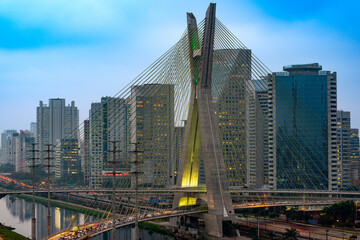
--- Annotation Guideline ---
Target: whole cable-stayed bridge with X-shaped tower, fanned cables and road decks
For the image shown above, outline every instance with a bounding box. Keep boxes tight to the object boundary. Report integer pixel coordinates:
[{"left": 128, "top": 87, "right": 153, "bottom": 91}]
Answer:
[{"left": 0, "top": 4, "right": 360, "bottom": 239}]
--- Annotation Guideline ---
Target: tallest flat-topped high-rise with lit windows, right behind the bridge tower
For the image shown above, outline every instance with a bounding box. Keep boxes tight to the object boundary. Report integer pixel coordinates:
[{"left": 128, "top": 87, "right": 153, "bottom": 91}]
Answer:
[{"left": 212, "top": 49, "right": 264, "bottom": 188}]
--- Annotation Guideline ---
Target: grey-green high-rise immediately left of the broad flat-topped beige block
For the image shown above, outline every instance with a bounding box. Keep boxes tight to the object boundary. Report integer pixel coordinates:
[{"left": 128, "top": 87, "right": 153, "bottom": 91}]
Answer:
[{"left": 89, "top": 97, "right": 130, "bottom": 188}]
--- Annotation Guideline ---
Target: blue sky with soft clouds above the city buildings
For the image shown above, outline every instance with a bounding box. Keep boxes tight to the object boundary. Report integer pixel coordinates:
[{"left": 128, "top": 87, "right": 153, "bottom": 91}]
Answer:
[{"left": 0, "top": 0, "right": 360, "bottom": 132}]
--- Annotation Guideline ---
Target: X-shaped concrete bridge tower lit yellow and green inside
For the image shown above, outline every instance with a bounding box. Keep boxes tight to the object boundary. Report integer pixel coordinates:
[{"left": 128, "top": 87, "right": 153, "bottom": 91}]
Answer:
[{"left": 174, "top": 3, "right": 234, "bottom": 237}]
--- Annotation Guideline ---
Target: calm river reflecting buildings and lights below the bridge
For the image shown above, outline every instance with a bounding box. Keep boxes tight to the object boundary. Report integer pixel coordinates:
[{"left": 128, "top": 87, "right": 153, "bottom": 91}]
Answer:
[{"left": 0, "top": 196, "right": 173, "bottom": 240}]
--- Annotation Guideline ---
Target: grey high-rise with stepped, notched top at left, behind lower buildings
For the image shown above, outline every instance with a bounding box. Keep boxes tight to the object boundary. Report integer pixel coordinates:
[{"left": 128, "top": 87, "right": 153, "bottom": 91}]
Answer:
[{"left": 36, "top": 98, "right": 79, "bottom": 151}]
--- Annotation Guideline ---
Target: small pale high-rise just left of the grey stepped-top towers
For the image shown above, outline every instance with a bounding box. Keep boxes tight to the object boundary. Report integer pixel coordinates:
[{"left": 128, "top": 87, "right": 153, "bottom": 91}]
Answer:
[{"left": 14, "top": 130, "right": 35, "bottom": 172}]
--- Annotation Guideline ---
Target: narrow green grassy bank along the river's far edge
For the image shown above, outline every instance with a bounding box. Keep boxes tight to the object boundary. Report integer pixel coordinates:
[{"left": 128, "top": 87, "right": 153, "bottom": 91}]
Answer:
[{"left": 15, "top": 194, "right": 107, "bottom": 218}]
